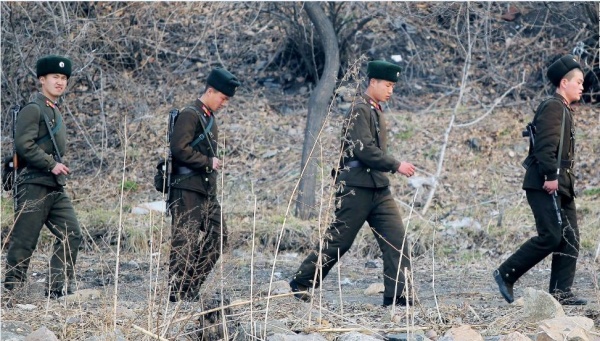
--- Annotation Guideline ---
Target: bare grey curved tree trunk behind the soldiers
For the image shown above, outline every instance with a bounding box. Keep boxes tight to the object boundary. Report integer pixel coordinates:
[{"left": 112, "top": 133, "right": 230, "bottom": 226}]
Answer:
[{"left": 296, "top": 2, "right": 340, "bottom": 219}]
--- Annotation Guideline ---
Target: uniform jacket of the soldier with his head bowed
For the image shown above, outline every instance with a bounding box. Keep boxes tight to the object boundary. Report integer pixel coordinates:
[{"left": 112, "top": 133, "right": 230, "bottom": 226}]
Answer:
[{"left": 170, "top": 99, "right": 219, "bottom": 195}]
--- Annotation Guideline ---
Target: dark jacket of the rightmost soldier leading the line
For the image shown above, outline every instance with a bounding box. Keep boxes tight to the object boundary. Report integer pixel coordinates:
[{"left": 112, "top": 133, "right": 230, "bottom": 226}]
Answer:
[{"left": 523, "top": 94, "right": 575, "bottom": 197}]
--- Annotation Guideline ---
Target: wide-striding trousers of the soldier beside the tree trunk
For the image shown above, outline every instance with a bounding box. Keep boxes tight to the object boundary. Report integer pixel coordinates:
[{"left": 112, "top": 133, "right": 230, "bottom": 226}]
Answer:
[{"left": 294, "top": 186, "right": 410, "bottom": 297}]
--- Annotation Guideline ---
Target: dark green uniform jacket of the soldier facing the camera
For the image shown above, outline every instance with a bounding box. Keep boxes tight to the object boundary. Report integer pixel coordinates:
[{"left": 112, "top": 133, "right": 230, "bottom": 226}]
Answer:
[{"left": 15, "top": 93, "right": 67, "bottom": 187}]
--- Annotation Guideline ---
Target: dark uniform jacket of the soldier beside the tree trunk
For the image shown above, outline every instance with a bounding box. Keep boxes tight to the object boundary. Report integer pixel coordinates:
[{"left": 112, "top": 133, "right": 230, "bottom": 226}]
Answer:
[{"left": 337, "top": 95, "right": 400, "bottom": 188}]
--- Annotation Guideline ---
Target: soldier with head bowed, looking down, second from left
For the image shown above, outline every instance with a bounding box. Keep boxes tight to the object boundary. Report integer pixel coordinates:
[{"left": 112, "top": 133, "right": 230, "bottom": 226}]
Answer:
[{"left": 169, "top": 68, "right": 240, "bottom": 302}]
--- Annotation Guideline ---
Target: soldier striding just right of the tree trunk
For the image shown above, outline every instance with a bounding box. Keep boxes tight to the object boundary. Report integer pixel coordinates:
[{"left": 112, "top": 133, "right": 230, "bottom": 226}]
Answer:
[{"left": 290, "top": 61, "right": 415, "bottom": 306}]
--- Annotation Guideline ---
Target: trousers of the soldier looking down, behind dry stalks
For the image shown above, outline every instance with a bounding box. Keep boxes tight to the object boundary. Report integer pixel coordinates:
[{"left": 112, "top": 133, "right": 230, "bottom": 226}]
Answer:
[{"left": 169, "top": 188, "right": 227, "bottom": 297}]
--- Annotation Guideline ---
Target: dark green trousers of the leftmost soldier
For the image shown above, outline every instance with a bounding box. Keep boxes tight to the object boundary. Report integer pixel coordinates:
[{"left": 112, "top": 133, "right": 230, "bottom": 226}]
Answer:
[{"left": 4, "top": 184, "right": 81, "bottom": 291}]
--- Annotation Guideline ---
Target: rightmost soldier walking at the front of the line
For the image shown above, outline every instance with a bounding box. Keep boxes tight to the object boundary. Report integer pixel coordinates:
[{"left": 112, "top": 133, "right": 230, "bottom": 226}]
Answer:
[{"left": 494, "top": 55, "right": 587, "bottom": 305}]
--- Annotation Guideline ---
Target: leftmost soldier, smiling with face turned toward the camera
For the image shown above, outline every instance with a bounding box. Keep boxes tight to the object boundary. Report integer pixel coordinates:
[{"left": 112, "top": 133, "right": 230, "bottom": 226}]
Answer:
[{"left": 4, "top": 55, "right": 81, "bottom": 298}]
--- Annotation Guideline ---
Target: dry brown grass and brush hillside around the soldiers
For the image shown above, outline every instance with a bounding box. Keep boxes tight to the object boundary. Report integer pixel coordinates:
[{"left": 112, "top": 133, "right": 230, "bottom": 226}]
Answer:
[{"left": 1, "top": 2, "right": 600, "bottom": 340}]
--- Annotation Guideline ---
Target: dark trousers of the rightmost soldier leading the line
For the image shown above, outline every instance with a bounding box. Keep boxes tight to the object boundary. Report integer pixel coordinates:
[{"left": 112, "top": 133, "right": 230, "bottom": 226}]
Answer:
[{"left": 498, "top": 190, "right": 579, "bottom": 293}]
